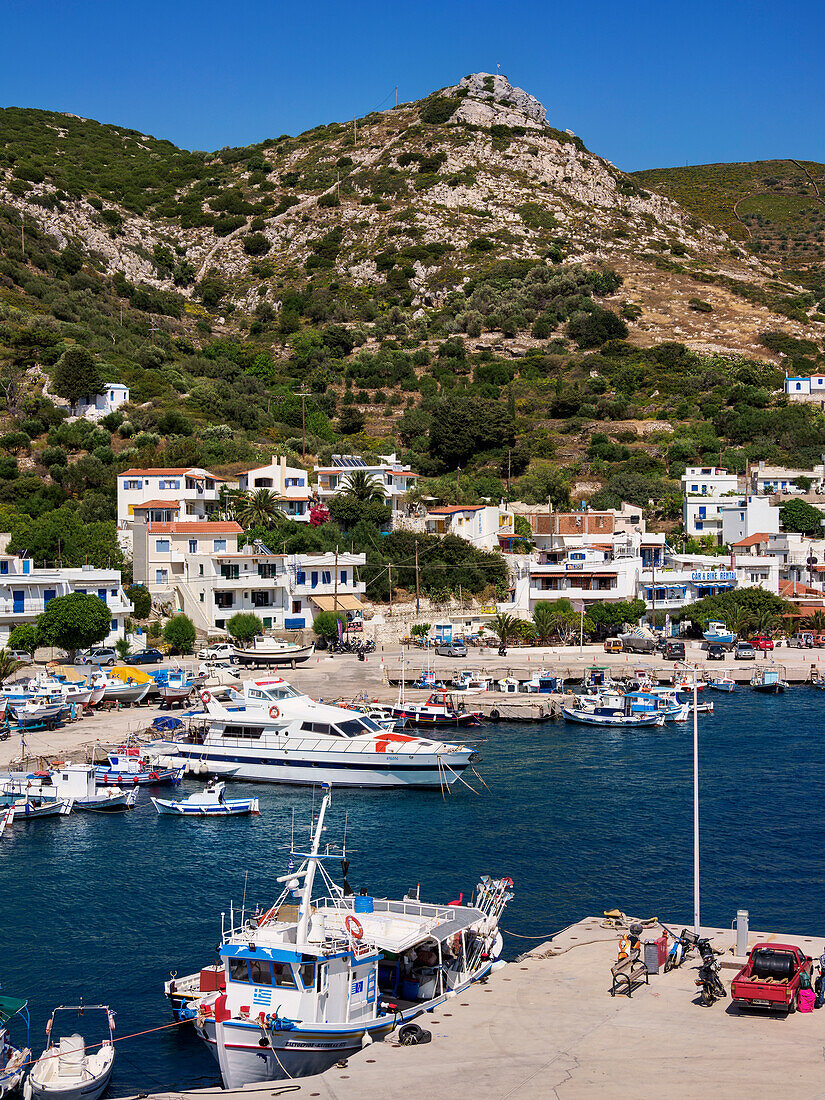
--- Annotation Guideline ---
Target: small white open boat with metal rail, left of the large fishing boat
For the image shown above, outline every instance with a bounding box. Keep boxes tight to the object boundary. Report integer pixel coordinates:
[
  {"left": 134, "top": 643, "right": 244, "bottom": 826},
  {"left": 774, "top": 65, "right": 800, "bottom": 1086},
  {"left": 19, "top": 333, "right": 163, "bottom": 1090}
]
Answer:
[{"left": 23, "top": 1004, "right": 114, "bottom": 1100}]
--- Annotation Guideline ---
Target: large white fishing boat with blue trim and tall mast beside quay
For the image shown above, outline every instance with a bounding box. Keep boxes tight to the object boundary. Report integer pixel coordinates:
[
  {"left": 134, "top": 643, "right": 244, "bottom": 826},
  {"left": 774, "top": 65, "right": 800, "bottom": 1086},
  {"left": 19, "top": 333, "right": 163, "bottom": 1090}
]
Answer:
[{"left": 166, "top": 790, "right": 513, "bottom": 1089}]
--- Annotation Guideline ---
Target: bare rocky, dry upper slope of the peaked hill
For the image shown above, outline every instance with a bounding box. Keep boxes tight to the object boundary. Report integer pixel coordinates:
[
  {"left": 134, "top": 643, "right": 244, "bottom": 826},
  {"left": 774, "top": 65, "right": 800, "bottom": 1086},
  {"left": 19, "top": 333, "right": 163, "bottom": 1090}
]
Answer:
[{"left": 0, "top": 74, "right": 825, "bottom": 353}]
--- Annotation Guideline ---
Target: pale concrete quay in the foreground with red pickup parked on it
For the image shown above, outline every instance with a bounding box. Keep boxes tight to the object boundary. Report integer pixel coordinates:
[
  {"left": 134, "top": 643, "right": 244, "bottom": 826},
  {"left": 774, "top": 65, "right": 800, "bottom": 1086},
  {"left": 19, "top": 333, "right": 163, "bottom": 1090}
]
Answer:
[{"left": 117, "top": 917, "right": 825, "bottom": 1100}]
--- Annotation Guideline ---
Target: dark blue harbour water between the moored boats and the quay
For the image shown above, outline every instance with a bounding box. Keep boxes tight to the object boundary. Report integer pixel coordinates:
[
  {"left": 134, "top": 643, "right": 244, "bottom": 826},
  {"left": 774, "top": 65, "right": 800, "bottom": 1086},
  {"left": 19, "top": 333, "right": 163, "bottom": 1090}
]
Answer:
[{"left": 0, "top": 688, "right": 825, "bottom": 1096}]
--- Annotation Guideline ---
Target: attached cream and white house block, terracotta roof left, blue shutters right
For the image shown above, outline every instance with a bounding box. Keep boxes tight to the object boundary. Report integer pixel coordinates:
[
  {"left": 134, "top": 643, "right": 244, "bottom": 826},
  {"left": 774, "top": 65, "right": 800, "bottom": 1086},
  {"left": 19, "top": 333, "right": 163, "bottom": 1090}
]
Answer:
[{"left": 133, "top": 520, "right": 366, "bottom": 634}]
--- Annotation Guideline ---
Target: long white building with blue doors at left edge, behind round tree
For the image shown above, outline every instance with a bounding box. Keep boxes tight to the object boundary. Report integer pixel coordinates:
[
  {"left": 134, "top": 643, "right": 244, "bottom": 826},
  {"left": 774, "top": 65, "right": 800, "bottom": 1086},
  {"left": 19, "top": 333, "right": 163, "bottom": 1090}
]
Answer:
[{"left": 0, "top": 554, "right": 132, "bottom": 647}]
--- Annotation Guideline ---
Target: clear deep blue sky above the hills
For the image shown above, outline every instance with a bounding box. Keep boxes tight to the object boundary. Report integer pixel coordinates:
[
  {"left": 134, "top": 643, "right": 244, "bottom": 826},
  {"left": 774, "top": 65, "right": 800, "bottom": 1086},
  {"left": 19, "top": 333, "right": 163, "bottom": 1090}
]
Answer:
[{"left": 0, "top": 0, "right": 825, "bottom": 171}]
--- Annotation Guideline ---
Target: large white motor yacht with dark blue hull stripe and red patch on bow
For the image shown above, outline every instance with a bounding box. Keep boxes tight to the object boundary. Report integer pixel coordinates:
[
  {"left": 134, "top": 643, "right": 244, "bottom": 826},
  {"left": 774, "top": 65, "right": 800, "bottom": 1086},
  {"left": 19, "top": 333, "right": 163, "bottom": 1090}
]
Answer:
[{"left": 145, "top": 677, "right": 479, "bottom": 789}]
